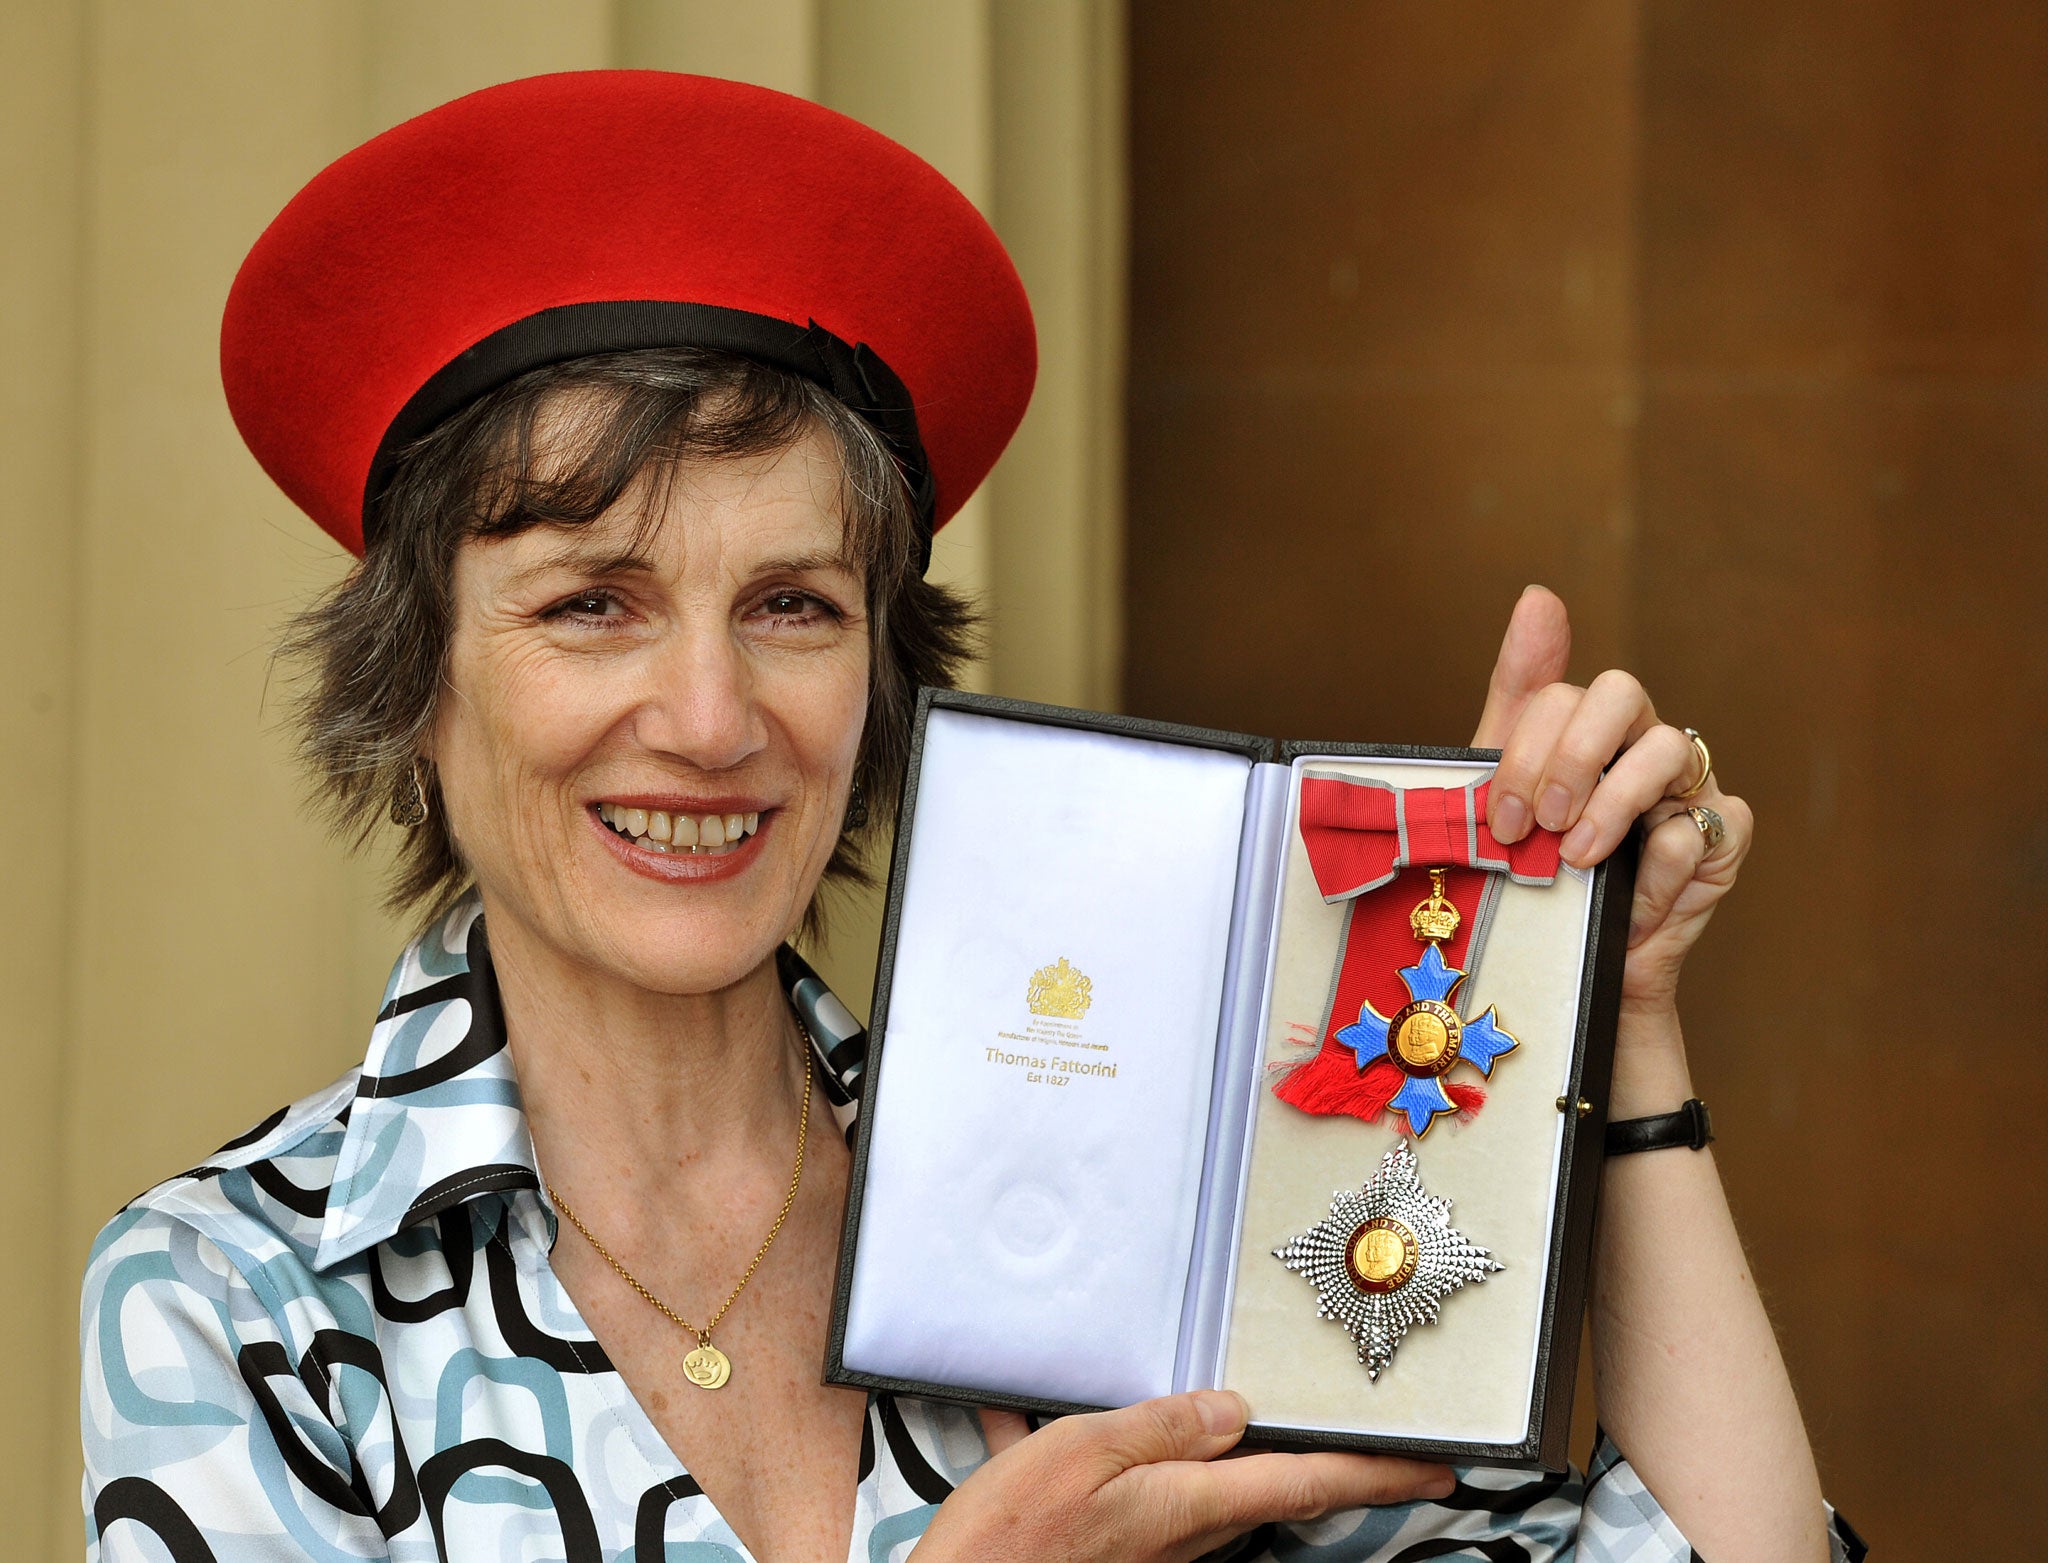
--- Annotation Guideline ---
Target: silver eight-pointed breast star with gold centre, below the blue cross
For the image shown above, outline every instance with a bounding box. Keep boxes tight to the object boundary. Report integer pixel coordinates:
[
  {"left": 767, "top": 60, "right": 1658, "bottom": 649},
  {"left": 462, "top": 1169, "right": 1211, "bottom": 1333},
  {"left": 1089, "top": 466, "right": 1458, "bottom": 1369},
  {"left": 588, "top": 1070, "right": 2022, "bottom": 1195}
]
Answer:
[{"left": 1274, "top": 1139, "right": 1507, "bottom": 1379}]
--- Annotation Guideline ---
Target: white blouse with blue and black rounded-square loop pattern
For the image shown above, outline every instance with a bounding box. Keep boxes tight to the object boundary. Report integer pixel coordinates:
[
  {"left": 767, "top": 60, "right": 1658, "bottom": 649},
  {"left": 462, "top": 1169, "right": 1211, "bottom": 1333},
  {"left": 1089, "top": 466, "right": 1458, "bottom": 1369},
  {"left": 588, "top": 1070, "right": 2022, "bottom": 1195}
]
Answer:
[{"left": 80, "top": 899, "right": 1860, "bottom": 1563}]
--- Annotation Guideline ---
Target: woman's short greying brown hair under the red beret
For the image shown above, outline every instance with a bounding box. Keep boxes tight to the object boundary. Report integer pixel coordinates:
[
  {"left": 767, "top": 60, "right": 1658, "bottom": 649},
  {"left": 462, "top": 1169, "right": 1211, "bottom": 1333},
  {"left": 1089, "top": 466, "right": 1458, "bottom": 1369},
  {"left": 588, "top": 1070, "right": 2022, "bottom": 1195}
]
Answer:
[{"left": 279, "top": 348, "right": 977, "bottom": 932}]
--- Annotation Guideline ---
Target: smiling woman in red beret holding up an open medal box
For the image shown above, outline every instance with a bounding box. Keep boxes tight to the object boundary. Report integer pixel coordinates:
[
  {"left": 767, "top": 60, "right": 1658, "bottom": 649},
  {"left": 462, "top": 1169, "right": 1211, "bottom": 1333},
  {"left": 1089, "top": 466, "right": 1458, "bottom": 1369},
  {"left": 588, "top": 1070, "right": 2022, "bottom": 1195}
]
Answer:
[{"left": 84, "top": 72, "right": 1845, "bottom": 1563}]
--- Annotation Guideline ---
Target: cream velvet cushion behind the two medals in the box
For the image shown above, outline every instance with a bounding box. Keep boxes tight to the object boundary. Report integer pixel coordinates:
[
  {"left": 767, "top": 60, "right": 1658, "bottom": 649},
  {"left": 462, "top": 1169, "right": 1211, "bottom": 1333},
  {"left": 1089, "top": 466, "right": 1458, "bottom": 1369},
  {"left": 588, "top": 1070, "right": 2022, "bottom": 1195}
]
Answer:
[{"left": 1221, "top": 760, "right": 1591, "bottom": 1444}]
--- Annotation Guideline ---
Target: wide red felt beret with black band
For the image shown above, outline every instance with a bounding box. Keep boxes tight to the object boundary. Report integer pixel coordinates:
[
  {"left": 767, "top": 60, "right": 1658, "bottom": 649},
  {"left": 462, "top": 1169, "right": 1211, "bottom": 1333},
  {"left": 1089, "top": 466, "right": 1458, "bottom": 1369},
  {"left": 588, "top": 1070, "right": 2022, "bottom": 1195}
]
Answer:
[{"left": 221, "top": 70, "right": 1038, "bottom": 553}]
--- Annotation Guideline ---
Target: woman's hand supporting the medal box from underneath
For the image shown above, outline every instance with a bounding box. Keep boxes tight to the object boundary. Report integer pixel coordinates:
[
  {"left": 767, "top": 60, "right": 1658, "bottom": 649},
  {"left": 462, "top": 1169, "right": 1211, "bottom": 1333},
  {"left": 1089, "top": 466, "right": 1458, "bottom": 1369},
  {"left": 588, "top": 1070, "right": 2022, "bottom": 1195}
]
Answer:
[{"left": 915, "top": 1389, "right": 1452, "bottom": 1563}]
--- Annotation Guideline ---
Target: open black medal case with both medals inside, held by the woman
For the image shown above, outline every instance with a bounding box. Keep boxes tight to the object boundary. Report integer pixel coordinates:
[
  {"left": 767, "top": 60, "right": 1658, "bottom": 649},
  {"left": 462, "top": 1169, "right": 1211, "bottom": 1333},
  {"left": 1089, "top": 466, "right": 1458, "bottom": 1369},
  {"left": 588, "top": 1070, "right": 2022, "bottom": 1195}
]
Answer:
[{"left": 825, "top": 690, "right": 1634, "bottom": 1469}]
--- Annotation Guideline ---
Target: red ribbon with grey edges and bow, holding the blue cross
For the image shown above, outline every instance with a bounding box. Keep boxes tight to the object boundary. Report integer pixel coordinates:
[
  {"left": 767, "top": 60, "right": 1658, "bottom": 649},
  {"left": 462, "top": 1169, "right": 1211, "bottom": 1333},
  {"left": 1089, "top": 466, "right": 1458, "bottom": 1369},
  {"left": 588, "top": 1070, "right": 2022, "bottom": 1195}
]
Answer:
[{"left": 1274, "top": 774, "right": 1561, "bottom": 1123}]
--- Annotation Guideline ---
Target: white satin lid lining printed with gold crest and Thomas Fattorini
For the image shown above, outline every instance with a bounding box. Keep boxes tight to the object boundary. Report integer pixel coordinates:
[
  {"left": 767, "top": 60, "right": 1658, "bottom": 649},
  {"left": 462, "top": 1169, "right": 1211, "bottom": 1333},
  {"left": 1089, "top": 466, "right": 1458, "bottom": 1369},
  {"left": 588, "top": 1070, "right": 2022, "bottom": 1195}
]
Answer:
[{"left": 842, "top": 709, "right": 1251, "bottom": 1405}]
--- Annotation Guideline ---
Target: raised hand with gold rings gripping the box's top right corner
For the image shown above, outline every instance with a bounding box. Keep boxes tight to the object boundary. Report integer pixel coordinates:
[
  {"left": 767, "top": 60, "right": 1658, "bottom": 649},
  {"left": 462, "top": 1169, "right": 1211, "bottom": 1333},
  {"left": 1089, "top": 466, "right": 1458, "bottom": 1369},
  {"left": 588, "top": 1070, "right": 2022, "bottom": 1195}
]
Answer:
[{"left": 1473, "top": 586, "right": 1753, "bottom": 1008}]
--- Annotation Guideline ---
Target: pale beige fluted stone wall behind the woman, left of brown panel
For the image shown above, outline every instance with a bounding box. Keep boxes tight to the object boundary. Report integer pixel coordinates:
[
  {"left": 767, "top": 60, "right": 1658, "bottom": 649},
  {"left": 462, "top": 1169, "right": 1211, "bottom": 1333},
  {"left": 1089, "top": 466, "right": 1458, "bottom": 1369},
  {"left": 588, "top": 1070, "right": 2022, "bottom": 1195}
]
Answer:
[{"left": 0, "top": 0, "right": 1122, "bottom": 1557}]
